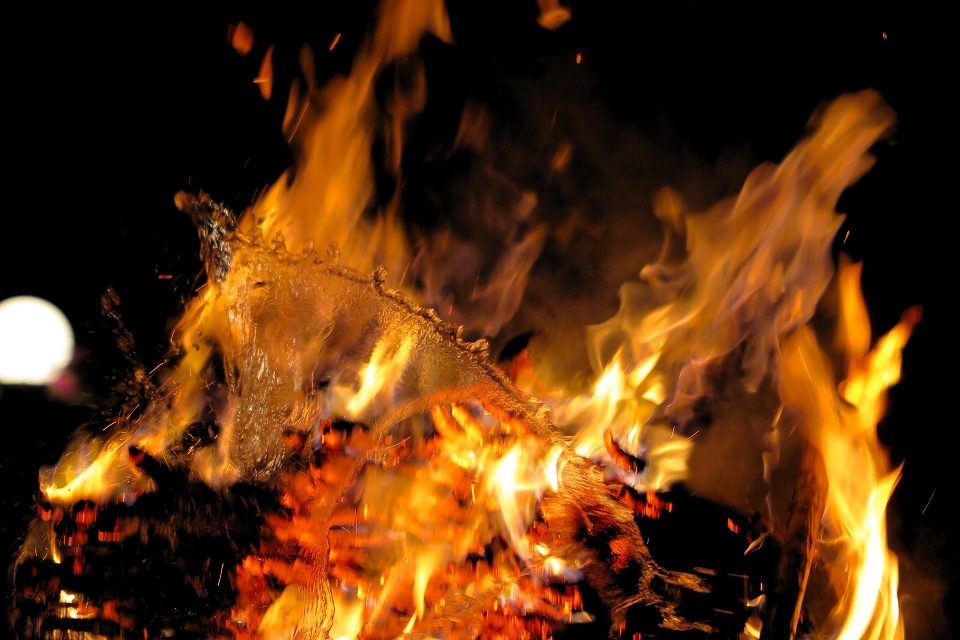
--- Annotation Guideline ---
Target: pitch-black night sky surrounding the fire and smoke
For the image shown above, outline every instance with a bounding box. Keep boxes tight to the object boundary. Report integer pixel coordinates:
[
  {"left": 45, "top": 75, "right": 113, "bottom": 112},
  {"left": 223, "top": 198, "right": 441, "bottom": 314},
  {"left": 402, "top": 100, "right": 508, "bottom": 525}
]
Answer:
[{"left": 0, "top": 1, "right": 957, "bottom": 636}]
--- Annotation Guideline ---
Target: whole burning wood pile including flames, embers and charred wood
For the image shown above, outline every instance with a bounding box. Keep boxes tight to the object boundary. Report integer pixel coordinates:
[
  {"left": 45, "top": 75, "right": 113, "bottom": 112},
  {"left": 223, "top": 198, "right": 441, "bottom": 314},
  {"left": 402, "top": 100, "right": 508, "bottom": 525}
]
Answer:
[{"left": 13, "top": 1, "right": 919, "bottom": 639}]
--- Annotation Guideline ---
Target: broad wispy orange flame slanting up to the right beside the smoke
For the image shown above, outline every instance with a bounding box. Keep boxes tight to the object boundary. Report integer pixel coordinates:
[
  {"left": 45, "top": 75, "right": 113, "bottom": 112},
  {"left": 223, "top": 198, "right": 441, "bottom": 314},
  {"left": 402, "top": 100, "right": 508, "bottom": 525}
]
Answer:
[{"left": 527, "top": 91, "right": 892, "bottom": 500}]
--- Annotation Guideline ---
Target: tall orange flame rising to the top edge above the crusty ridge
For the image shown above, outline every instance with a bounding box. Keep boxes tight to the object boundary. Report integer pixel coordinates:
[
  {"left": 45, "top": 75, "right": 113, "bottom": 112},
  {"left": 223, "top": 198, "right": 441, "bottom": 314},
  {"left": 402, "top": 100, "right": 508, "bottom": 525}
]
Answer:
[{"left": 248, "top": 0, "right": 451, "bottom": 274}]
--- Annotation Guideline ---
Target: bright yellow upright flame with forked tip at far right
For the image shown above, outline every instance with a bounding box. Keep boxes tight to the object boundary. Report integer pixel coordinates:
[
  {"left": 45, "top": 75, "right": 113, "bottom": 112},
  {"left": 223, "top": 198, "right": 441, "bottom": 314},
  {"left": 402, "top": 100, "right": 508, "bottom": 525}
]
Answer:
[{"left": 781, "top": 261, "right": 920, "bottom": 640}]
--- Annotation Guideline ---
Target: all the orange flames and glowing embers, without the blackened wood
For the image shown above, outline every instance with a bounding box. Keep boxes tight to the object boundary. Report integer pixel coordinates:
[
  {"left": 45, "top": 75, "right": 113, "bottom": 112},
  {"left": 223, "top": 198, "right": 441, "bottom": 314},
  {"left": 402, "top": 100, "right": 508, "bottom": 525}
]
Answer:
[{"left": 11, "top": 0, "right": 920, "bottom": 639}]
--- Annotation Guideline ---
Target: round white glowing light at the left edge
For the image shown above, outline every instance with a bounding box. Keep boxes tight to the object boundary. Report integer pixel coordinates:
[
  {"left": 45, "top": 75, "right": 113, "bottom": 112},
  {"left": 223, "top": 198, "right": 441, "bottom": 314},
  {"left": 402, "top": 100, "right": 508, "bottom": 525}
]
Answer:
[{"left": 0, "top": 296, "right": 73, "bottom": 384}]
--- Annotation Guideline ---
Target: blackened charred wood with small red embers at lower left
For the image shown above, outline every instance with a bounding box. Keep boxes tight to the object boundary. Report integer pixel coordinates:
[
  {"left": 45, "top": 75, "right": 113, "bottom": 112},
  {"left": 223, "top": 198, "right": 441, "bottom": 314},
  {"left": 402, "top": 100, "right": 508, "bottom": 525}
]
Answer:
[{"left": 10, "top": 452, "right": 278, "bottom": 639}]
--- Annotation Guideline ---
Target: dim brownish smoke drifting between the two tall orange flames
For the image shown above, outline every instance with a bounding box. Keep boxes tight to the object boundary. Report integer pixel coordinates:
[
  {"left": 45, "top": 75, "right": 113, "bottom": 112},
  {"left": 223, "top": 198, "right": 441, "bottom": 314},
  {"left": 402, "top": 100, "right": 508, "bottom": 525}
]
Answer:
[{"left": 405, "top": 38, "right": 751, "bottom": 380}]
